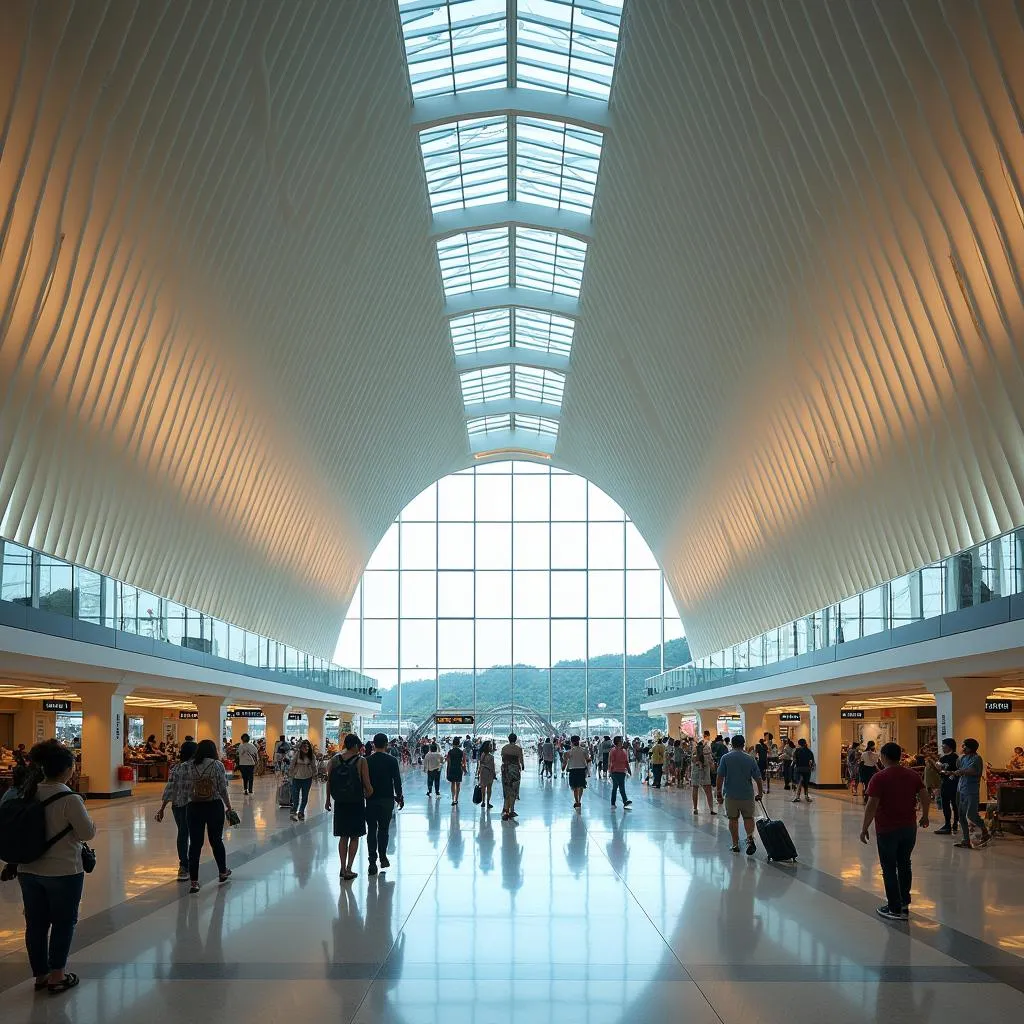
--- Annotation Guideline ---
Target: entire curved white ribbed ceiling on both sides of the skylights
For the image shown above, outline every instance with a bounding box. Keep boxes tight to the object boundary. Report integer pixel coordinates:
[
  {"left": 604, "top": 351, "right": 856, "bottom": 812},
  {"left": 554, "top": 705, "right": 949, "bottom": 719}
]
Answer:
[{"left": 0, "top": 0, "right": 1024, "bottom": 656}]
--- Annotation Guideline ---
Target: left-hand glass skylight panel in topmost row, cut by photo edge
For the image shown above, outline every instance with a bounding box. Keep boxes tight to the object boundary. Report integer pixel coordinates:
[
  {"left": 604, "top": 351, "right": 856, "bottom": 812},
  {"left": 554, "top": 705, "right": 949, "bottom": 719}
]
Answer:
[{"left": 398, "top": 0, "right": 508, "bottom": 99}]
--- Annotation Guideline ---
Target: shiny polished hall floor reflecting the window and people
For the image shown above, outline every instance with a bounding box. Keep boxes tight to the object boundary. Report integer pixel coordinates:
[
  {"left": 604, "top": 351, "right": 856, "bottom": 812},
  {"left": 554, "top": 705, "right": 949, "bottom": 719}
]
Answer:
[{"left": 0, "top": 771, "right": 1024, "bottom": 1024}]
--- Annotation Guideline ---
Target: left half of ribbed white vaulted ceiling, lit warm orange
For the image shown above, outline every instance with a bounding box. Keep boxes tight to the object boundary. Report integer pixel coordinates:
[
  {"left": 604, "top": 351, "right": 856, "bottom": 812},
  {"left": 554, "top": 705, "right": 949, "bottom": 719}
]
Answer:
[{"left": 0, "top": 0, "right": 468, "bottom": 656}]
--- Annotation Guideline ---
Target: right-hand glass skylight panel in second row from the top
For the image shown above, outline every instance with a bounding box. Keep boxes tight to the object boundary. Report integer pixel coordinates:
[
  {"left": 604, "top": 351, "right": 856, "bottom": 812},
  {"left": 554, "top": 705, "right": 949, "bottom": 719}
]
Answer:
[{"left": 515, "top": 117, "right": 602, "bottom": 214}]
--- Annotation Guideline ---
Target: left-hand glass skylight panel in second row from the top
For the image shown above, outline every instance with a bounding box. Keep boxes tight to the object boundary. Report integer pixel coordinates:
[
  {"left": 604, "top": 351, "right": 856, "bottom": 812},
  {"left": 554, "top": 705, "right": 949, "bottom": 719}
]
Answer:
[{"left": 420, "top": 117, "right": 509, "bottom": 213}]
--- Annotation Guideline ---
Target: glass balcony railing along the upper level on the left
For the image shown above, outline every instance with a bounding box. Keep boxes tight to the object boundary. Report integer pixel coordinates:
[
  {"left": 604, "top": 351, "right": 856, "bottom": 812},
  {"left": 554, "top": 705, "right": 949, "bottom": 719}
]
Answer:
[{"left": 0, "top": 541, "right": 379, "bottom": 700}]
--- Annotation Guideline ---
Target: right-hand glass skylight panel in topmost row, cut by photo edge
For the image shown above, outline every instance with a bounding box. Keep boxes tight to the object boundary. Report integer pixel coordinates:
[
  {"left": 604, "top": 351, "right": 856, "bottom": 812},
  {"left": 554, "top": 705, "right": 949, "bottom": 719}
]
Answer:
[{"left": 516, "top": 0, "right": 623, "bottom": 100}]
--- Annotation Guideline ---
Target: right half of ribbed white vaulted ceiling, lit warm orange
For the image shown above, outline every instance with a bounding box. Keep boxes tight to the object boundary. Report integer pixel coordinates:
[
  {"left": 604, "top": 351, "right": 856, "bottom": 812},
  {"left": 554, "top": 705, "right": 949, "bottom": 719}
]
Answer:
[{"left": 557, "top": 0, "right": 1024, "bottom": 654}]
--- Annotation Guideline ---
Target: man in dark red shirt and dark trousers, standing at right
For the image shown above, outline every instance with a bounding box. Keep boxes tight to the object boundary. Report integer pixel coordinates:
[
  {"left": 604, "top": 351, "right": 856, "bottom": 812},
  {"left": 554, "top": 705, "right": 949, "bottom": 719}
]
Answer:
[{"left": 860, "top": 743, "right": 931, "bottom": 921}]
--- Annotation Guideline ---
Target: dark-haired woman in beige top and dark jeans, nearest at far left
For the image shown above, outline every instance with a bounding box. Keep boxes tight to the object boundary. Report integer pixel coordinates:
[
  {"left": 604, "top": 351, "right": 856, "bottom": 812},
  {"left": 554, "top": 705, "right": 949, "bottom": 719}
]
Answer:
[{"left": 9, "top": 739, "right": 96, "bottom": 995}]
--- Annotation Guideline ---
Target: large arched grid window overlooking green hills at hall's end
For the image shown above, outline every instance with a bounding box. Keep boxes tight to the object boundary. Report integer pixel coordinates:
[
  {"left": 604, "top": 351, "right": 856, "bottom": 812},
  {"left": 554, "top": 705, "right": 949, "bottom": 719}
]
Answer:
[{"left": 338, "top": 462, "right": 689, "bottom": 734}]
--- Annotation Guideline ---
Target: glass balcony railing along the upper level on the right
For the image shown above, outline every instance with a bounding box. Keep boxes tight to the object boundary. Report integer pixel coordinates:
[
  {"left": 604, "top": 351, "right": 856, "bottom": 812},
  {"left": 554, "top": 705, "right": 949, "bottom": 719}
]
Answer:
[{"left": 647, "top": 528, "right": 1024, "bottom": 698}]
